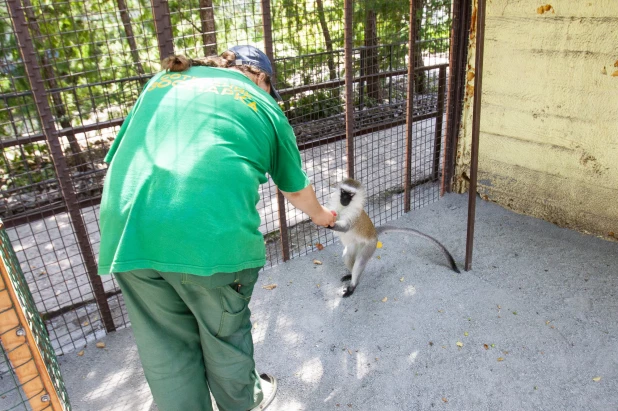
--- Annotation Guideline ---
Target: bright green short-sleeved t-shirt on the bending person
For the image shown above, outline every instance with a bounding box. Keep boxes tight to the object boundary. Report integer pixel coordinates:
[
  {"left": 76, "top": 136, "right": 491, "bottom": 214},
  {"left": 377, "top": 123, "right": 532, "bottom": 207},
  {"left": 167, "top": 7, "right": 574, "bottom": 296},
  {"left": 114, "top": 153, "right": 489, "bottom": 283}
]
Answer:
[{"left": 99, "top": 67, "right": 309, "bottom": 275}]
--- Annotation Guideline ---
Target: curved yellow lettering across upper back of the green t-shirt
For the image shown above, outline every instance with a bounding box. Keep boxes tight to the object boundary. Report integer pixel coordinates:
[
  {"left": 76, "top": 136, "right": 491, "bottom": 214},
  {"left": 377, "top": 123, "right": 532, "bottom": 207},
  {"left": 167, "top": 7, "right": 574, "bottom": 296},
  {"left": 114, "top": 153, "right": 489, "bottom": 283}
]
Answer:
[{"left": 147, "top": 73, "right": 257, "bottom": 113}]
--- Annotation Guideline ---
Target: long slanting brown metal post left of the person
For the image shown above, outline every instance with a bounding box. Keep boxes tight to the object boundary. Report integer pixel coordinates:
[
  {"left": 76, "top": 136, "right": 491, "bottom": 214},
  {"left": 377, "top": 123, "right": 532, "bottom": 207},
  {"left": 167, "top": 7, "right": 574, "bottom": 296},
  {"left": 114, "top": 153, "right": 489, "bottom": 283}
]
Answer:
[{"left": 7, "top": 0, "right": 116, "bottom": 332}]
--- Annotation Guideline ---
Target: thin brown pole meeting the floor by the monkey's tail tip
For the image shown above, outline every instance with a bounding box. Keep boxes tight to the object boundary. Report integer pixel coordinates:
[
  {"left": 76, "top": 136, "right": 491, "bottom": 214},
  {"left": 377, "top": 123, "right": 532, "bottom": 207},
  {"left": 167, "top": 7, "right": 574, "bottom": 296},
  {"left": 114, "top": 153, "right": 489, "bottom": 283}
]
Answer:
[{"left": 465, "top": 0, "right": 487, "bottom": 271}]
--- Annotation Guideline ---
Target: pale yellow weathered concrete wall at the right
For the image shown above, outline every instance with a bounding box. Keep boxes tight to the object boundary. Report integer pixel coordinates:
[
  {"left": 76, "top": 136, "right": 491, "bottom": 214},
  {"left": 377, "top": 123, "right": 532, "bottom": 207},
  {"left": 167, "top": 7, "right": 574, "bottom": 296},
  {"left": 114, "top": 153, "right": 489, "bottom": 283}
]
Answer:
[{"left": 455, "top": 0, "right": 618, "bottom": 239}]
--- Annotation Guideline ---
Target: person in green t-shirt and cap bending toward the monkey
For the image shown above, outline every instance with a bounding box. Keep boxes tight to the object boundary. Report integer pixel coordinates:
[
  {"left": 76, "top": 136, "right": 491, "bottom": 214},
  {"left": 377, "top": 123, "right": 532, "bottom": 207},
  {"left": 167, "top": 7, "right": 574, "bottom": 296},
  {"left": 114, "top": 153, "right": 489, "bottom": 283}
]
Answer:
[{"left": 99, "top": 46, "right": 335, "bottom": 411}]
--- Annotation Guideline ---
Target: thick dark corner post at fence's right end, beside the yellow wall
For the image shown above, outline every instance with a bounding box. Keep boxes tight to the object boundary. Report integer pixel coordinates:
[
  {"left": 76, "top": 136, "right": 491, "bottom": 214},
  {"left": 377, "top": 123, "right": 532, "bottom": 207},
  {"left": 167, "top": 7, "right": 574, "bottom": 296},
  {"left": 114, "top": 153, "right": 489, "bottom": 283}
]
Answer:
[{"left": 442, "top": 0, "right": 471, "bottom": 193}]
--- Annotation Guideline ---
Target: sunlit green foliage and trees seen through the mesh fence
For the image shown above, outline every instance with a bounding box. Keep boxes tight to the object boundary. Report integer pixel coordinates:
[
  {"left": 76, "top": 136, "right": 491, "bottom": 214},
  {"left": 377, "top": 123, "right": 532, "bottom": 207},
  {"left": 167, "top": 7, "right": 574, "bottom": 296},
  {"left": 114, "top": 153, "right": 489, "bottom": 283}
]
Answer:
[{"left": 0, "top": 0, "right": 451, "bottom": 198}]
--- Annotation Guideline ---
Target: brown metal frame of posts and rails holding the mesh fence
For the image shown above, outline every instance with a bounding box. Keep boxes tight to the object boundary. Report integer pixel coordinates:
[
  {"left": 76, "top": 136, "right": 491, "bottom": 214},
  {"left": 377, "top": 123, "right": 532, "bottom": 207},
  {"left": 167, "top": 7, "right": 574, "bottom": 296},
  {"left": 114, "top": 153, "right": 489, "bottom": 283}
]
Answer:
[{"left": 0, "top": 0, "right": 470, "bottom": 354}]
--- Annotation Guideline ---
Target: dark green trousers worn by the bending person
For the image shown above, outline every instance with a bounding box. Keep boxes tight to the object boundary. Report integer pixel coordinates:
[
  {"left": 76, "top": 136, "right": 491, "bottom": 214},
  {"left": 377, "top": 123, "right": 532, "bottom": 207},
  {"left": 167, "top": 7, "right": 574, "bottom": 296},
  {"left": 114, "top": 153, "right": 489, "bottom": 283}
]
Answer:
[{"left": 116, "top": 268, "right": 263, "bottom": 411}]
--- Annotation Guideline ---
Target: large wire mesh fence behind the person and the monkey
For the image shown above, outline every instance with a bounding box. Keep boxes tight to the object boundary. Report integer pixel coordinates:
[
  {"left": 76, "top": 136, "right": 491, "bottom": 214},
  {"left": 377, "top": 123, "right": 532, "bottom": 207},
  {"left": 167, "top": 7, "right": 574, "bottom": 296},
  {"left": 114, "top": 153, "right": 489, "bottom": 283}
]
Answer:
[{"left": 0, "top": 0, "right": 459, "bottom": 353}]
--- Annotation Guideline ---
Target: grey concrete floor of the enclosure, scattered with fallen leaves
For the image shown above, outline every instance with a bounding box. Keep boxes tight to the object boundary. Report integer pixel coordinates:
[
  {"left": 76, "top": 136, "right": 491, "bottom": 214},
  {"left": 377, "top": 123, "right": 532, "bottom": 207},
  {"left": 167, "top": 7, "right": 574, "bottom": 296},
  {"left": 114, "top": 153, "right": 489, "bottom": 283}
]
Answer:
[{"left": 59, "top": 195, "right": 618, "bottom": 411}]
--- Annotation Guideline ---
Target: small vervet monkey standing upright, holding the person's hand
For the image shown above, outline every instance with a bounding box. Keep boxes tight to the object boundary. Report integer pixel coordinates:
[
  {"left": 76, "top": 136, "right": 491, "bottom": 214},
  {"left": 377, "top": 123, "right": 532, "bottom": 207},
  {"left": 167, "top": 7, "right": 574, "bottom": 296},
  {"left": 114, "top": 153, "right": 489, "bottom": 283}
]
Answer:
[{"left": 328, "top": 178, "right": 459, "bottom": 297}]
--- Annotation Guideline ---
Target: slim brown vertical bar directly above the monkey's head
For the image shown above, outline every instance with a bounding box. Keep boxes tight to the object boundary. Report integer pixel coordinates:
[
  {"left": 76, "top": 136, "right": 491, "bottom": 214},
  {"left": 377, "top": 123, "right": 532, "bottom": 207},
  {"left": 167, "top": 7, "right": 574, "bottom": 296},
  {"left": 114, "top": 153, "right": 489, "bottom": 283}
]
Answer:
[{"left": 343, "top": 0, "right": 355, "bottom": 178}]
